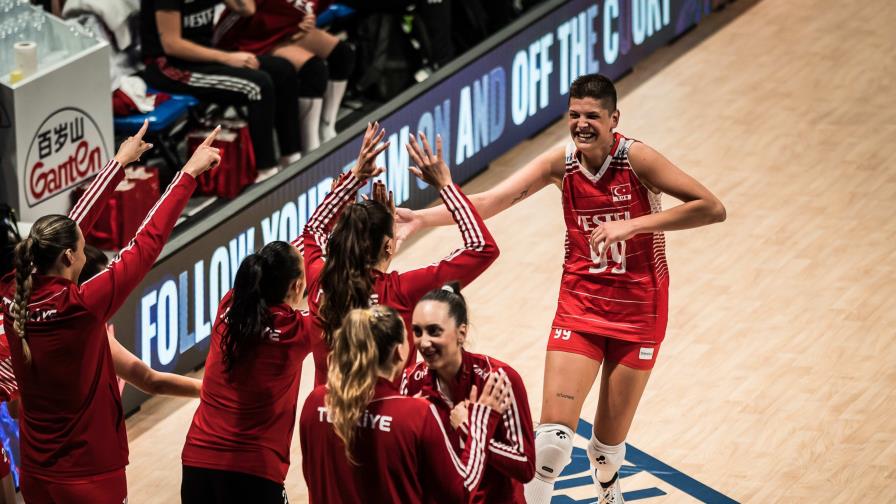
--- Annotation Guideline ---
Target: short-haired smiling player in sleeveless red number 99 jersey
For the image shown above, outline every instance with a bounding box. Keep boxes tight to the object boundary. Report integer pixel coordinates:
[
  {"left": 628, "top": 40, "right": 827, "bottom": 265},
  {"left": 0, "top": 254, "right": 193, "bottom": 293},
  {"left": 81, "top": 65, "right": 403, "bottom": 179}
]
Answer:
[{"left": 396, "top": 74, "right": 725, "bottom": 504}]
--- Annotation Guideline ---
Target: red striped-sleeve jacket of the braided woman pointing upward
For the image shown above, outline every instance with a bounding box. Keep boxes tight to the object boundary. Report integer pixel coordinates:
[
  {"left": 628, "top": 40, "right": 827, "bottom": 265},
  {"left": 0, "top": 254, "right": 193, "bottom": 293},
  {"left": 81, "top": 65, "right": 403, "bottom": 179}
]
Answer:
[{"left": 0, "top": 160, "right": 196, "bottom": 479}]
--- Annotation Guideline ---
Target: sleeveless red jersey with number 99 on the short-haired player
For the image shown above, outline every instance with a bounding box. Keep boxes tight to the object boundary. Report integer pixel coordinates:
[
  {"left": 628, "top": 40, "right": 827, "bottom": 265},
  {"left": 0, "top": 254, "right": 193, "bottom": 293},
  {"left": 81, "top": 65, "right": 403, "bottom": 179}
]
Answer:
[{"left": 553, "top": 133, "right": 669, "bottom": 343}]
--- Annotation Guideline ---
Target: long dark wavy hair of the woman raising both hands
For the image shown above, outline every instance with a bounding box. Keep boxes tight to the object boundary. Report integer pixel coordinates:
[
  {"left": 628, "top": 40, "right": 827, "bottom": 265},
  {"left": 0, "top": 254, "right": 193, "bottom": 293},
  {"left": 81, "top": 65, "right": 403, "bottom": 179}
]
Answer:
[{"left": 319, "top": 200, "right": 393, "bottom": 348}]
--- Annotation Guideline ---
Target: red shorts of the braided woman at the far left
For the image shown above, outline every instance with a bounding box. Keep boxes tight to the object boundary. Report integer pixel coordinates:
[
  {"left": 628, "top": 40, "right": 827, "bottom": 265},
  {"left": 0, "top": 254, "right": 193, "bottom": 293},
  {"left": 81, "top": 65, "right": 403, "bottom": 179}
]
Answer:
[{"left": 20, "top": 468, "right": 128, "bottom": 504}]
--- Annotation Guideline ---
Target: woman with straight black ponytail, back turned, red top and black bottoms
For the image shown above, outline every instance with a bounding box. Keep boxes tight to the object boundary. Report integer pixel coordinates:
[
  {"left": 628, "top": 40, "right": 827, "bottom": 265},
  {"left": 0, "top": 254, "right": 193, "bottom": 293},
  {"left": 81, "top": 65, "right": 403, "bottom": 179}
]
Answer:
[{"left": 181, "top": 241, "right": 317, "bottom": 504}]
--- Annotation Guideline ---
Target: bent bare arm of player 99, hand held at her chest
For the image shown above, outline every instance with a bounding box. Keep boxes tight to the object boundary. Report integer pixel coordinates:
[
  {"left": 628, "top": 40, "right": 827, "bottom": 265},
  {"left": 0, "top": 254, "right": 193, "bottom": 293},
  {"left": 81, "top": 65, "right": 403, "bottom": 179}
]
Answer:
[{"left": 591, "top": 142, "right": 726, "bottom": 254}]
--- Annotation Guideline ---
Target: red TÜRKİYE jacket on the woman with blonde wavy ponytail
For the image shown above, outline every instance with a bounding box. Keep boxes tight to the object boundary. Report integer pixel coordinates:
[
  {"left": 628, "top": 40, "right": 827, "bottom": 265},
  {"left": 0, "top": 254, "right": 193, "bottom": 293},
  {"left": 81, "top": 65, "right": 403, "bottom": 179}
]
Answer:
[{"left": 299, "top": 378, "right": 499, "bottom": 504}]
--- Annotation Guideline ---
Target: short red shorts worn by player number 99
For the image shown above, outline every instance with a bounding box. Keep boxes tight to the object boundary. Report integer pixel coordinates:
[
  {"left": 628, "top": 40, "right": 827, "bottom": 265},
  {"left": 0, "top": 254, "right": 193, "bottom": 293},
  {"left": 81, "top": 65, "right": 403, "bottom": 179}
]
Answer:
[{"left": 548, "top": 327, "right": 660, "bottom": 370}]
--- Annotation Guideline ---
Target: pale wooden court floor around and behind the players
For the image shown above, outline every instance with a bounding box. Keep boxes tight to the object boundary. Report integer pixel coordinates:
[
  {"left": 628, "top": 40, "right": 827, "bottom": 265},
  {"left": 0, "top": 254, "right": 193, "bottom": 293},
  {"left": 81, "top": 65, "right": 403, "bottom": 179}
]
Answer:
[{"left": 122, "top": 0, "right": 896, "bottom": 504}]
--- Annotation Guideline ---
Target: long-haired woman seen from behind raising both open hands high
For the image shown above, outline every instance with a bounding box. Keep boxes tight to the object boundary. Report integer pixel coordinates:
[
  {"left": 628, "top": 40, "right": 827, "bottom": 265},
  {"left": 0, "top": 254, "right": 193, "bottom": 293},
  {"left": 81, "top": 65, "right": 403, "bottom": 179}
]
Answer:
[{"left": 303, "top": 123, "right": 499, "bottom": 385}]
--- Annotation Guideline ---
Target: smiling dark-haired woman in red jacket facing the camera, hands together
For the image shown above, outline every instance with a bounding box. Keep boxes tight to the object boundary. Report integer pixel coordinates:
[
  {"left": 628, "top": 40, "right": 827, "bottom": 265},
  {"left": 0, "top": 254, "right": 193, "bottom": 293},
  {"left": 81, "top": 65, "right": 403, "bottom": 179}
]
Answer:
[{"left": 401, "top": 283, "right": 535, "bottom": 504}]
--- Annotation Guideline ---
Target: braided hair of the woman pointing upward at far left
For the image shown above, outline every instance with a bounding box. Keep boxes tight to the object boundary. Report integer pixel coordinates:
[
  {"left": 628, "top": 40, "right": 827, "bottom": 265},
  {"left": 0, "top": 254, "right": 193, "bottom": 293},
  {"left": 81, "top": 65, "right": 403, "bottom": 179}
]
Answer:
[{"left": 9, "top": 215, "right": 78, "bottom": 364}]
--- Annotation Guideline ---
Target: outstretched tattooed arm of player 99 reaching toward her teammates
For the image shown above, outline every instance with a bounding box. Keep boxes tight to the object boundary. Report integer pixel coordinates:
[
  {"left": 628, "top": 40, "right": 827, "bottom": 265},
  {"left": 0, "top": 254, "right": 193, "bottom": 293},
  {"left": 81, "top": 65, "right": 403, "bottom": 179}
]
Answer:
[{"left": 396, "top": 138, "right": 565, "bottom": 242}]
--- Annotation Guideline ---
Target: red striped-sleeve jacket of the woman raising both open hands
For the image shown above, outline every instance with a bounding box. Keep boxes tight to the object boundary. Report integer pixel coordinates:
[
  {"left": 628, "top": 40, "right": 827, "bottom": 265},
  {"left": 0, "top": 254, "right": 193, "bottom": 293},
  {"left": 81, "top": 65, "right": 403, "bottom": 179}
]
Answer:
[{"left": 302, "top": 174, "right": 499, "bottom": 385}]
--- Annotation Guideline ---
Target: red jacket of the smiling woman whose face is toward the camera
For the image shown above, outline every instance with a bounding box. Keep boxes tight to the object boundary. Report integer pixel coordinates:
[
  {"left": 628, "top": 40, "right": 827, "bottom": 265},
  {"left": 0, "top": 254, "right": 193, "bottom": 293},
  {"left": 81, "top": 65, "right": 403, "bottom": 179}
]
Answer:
[{"left": 401, "top": 352, "right": 535, "bottom": 503}]
